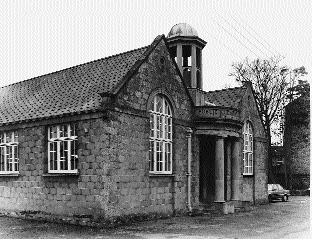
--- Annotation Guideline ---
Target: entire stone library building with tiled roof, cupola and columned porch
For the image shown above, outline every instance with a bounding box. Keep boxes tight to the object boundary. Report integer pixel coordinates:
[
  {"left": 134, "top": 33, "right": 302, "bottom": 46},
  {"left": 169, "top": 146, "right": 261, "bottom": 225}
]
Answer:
[{"left": 0, "top": 23, "right": 267, "bottom": 218}]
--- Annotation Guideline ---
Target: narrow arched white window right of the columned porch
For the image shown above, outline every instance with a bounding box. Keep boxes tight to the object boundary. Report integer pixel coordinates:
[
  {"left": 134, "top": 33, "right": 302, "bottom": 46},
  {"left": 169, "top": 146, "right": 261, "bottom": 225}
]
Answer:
[{"left": 243, "top": 122, "right": 253, "bottom": 175}]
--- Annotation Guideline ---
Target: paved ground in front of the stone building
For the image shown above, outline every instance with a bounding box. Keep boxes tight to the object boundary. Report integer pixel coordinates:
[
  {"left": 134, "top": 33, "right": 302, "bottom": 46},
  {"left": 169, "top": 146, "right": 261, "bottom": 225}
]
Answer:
[{"left": 0, "top": 196, "right": 312, "bottom": 239}]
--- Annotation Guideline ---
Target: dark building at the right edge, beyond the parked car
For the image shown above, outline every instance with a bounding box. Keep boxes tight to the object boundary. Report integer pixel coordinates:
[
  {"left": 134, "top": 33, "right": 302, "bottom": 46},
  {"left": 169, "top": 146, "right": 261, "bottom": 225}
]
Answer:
[{"left": 284, "top": 94, "right": 310, "bottom": 190}]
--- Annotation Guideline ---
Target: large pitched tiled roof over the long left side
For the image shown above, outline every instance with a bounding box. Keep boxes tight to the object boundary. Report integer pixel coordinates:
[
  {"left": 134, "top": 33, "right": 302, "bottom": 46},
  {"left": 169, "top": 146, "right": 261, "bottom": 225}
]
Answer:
[{"left": 0, "top": 47, "right": 148, "bottom": 124}]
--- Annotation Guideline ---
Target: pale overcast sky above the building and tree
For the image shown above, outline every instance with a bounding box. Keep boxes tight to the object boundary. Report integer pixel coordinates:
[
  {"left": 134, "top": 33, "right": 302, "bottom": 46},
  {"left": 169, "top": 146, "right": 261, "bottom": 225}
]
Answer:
[{"left": 0, "top": 0, "right": 312, "bottom": 90}]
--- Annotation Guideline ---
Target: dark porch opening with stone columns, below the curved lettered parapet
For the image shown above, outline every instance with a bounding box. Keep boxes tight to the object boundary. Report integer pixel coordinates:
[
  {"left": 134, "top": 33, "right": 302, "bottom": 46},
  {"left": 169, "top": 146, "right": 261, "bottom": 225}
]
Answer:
[{"left": 198, "top": 134, "right": 241, "bottom": 214}]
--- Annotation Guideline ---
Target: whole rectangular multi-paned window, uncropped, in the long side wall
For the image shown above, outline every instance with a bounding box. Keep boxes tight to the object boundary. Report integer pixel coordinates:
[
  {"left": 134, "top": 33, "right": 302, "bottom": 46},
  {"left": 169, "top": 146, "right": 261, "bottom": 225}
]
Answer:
[{"left": 48, "top": 124, "right": 78, "bottom": 173}]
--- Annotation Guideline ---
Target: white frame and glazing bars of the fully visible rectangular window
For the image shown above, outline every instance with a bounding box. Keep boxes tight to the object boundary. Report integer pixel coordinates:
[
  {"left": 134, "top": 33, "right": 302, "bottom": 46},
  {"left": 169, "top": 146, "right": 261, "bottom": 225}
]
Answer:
[{"left": 48, "top": 124, "right": 78, "bottom": 173}]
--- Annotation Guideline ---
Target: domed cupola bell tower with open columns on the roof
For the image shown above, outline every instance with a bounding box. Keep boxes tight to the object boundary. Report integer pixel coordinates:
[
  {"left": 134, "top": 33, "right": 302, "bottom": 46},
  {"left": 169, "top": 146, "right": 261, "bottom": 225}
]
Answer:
[{"left": 167, "top": 23, "right": 207, "bottom": 90}]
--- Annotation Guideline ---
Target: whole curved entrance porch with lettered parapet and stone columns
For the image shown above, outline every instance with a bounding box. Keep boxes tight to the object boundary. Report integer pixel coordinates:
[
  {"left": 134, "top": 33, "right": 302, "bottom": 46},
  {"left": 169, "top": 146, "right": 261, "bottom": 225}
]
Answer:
[{"left": 195, "top": 102, "right": 243, "bottom": 214}]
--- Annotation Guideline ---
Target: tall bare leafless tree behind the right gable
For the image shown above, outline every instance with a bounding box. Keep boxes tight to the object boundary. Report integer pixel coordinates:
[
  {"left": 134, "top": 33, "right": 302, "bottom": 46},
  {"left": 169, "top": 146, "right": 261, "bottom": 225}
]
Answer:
[{"left": 230, "top": 57, "right": 294, "bottom": 183}]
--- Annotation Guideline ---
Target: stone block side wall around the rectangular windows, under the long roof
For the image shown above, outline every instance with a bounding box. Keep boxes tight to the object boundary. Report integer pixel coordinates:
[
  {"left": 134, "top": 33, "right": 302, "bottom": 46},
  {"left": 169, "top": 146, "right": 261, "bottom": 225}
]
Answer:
[{"left": 0, "top": 115, "right": 113, "bottom": 218}]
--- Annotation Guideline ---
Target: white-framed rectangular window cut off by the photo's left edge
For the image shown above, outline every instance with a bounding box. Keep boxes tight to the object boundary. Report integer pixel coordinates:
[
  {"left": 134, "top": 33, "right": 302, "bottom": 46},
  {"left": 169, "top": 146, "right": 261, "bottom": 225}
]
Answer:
[{"left": 0, "top": 131, "right": 19, "bottom": 175}]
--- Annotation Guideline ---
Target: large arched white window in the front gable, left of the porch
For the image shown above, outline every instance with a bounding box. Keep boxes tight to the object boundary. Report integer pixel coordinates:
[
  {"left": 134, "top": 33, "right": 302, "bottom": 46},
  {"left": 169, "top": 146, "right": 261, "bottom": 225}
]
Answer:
[{"left": 149, "top": 95, "right": 172, "bottom": 174}]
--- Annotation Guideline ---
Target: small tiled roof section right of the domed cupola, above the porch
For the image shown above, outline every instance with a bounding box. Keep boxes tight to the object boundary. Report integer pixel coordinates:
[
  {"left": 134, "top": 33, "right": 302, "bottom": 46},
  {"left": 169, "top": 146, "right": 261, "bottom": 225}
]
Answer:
[{"left": 205, "top": 86, "right": 246, "bottom": 108}]
